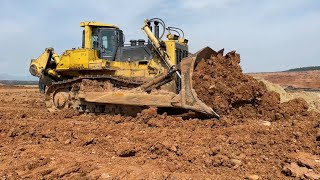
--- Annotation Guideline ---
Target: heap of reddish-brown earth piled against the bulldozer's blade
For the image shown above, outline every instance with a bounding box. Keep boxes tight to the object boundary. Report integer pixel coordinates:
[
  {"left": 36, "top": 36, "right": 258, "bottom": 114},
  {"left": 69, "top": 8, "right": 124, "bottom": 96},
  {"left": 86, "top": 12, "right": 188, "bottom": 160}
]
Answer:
[{"left": 193, "top": 49, "right": 308, "bottom": 120}]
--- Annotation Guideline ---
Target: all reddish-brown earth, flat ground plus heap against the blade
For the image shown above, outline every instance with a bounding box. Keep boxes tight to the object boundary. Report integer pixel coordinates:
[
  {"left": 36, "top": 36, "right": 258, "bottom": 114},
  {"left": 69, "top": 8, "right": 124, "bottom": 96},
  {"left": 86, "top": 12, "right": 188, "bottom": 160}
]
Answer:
[{"left": 0, "top": 51, "right": 320, "bottom": 179}]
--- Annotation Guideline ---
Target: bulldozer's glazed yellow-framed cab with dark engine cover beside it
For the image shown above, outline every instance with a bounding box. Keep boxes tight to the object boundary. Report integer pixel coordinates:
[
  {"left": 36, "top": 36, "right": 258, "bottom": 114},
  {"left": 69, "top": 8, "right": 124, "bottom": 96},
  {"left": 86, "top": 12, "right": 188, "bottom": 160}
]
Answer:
[{"left": 80, "top": 22, "right": 153, "bottom": 61}]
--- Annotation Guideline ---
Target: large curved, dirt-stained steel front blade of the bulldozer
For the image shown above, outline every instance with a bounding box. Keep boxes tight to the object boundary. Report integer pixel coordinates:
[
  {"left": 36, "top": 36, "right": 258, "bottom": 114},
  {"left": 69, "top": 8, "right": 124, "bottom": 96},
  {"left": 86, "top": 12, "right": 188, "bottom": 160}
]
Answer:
[{"left": 172, "top": 47, "right": 220, "bottom": 118}]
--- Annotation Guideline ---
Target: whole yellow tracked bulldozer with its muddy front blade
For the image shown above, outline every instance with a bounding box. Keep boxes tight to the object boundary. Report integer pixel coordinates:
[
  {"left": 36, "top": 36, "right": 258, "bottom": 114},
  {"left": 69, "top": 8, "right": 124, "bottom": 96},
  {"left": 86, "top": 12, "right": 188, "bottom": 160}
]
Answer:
[{"left": 29, "top": 18, "right": 219, "bottom": 117}]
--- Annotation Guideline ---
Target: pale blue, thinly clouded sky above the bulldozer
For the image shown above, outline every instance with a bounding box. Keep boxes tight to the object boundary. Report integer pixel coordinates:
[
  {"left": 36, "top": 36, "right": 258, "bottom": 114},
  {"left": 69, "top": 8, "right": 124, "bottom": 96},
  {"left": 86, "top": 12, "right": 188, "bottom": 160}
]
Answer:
[{"left": 0, "top": 0, "right": 320, "bottom": 76}]
